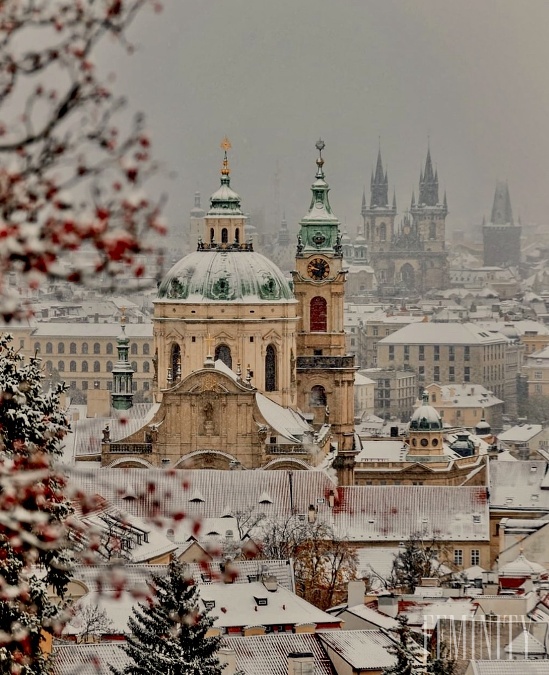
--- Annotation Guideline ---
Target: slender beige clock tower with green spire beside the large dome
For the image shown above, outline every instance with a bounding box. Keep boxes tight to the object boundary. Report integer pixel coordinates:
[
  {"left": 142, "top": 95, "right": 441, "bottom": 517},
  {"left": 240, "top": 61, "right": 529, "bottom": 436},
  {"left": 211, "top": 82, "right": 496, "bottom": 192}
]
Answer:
[{"left": 292, "top": 140, "right": 356, "bottom": 485}]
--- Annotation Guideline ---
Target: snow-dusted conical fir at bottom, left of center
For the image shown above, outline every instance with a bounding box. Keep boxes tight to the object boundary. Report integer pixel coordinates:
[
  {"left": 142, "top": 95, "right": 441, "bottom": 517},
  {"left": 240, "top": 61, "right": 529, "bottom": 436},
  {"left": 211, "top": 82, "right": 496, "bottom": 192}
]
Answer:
[{"left": 111, "top": 562, "right": 223, "bottom": 675}]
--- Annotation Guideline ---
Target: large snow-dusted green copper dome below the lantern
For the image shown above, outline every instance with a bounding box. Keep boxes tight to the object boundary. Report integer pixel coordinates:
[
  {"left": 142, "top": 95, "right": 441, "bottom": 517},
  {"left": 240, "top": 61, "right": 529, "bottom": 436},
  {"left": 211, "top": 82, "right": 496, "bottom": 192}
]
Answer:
[{"left": 158, "top": 249, "right": 295, "bottom": 303}]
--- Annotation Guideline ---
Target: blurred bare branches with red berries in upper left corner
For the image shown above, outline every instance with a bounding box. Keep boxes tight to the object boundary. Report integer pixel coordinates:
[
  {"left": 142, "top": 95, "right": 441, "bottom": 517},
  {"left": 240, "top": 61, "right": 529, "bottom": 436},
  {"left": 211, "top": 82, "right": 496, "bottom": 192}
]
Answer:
[{"left": 0, "top": 0, "right": 164, "bottom": 320}]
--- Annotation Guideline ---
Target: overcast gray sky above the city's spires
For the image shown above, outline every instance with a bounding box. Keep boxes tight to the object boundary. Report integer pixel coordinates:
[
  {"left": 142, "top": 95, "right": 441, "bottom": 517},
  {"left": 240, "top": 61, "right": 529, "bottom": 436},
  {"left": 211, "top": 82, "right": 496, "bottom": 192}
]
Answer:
[{"left": 109, "top": 0, "right": 549, "bottom": 244}]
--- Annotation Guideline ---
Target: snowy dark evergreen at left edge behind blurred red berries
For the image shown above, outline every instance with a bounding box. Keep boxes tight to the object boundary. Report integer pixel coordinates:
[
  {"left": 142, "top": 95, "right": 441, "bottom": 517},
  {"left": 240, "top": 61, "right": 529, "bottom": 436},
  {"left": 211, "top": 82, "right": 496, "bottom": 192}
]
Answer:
[{"left": 0, "top": 335, "right": 70, "bottom": 675}]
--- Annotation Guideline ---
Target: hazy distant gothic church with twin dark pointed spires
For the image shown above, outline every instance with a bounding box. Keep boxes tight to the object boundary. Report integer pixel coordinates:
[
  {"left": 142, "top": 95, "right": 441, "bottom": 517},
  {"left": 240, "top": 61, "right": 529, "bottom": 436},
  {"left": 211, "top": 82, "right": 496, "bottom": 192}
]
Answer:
[{"left": 361, "top": 149, "right": 448, "bottom": 297}]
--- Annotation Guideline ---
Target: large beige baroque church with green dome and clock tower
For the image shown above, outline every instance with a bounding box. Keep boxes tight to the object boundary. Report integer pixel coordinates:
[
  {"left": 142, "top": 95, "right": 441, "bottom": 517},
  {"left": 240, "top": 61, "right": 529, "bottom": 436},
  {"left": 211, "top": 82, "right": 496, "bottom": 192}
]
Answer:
[{"left": 101, "top": 142, "right": 356, "bottom": 484}]
